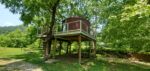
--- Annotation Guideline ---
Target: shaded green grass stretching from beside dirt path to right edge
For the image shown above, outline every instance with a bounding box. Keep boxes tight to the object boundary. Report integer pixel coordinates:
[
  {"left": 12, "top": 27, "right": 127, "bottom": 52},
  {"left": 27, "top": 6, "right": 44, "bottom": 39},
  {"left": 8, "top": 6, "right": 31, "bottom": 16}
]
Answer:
[{"left": 8, "top": 53, "right": 150, "bottom": 71}]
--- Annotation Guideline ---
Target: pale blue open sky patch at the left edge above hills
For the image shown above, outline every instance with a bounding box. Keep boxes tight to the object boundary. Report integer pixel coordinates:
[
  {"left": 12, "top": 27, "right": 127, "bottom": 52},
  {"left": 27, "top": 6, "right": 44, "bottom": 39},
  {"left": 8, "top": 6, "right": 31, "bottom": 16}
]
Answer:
[{"left": 0, "top": 4, "right": 22, "bottom": 26}]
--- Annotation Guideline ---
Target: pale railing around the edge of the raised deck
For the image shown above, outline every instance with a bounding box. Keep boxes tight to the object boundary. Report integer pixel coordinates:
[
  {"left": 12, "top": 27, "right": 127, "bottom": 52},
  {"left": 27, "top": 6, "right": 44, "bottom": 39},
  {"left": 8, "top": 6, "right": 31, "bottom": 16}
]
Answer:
[{"left": 37, "top": 20, "right": 95, "bottom": 38}]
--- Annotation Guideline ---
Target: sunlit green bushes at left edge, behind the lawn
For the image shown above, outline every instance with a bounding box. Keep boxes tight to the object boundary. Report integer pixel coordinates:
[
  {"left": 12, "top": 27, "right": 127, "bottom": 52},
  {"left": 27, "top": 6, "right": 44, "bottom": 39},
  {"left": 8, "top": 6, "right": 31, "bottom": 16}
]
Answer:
[{"left": 0, "top": 26, "right": 38, "bottom": 47}]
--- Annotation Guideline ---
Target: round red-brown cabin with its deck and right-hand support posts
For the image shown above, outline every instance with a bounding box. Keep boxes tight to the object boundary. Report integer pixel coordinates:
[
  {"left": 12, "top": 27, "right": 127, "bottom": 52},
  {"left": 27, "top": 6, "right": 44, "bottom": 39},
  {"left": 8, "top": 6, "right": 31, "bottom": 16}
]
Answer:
[{"left": 54, "top": 17, "right": 96, "bottom": 63}]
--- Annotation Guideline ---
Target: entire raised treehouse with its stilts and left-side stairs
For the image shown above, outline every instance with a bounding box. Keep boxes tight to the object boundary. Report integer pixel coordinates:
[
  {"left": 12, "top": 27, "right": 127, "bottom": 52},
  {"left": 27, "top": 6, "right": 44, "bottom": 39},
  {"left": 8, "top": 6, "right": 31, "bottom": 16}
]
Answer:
[{"left": 40, "top": 16, "right": 96, "bottom": 63}]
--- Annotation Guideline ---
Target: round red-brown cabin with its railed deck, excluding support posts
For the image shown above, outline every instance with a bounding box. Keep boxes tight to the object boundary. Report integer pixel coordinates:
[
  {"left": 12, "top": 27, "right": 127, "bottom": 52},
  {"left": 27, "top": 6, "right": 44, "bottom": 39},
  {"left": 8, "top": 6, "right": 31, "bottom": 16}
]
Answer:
[{"left": 54, "top": 16, "right": 95, "bottom": 41}]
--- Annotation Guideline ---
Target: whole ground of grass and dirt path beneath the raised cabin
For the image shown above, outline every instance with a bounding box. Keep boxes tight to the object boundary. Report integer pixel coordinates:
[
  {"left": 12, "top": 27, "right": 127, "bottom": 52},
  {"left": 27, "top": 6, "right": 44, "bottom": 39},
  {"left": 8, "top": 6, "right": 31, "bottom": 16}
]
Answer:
[{"left": 0, "top": 48, "right": 150, "bottom": 71}]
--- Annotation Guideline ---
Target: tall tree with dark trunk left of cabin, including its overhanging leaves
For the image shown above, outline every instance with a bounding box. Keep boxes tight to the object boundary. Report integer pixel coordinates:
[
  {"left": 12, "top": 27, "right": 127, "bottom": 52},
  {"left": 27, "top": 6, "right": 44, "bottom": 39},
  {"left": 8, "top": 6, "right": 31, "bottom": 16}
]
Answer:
[{"left": 0, "top": 0, "right": 100, "bottom": 59}]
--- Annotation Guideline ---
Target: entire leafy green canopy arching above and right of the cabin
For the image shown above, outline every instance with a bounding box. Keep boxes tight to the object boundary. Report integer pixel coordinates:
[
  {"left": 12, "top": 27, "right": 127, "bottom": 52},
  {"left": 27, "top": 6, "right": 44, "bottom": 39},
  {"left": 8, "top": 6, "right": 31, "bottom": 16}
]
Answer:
[{"left": 0, "top": 0, "right": 150, "bottom": 51}]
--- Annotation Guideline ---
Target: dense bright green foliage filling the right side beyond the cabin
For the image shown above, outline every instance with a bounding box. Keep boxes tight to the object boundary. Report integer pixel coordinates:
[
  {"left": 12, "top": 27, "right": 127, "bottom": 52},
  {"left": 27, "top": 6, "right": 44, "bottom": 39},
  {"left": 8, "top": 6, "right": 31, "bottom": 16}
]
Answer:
[{"left": 101, "top": 0, "right": 150, "bottom": 52}]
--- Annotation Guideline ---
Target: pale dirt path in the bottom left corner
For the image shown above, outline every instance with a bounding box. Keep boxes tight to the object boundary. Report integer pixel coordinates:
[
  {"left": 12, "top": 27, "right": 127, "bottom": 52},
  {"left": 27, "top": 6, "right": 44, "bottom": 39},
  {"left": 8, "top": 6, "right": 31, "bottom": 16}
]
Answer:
[{"left": 0, "top": 59, "right": 42, "bottom": 71}]
